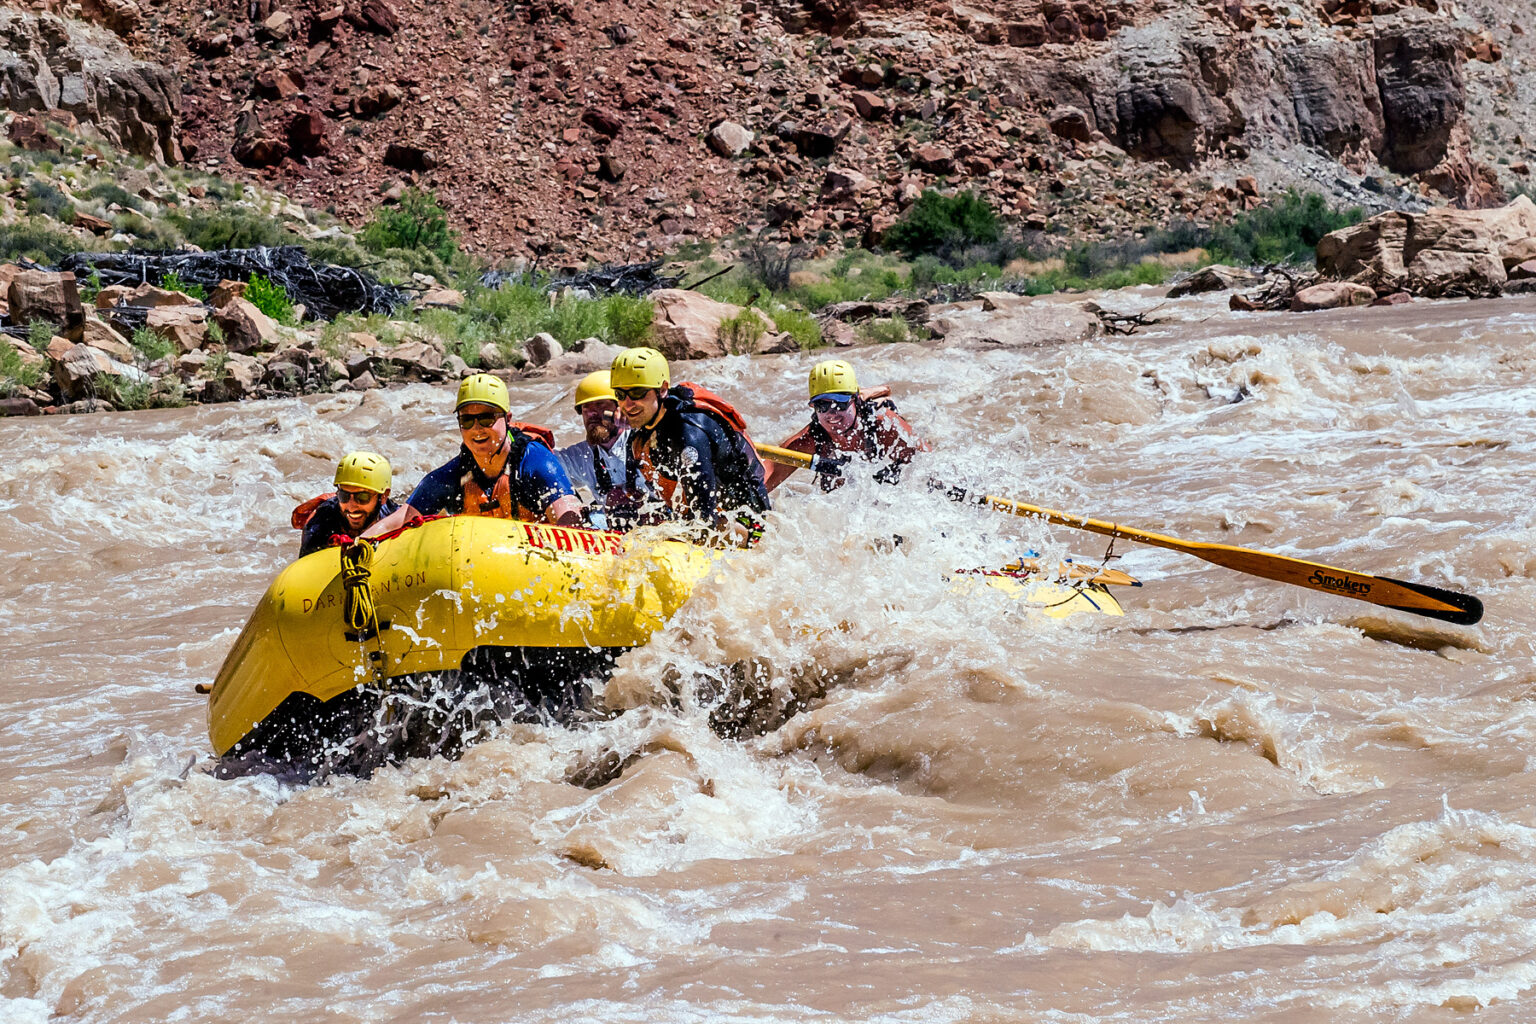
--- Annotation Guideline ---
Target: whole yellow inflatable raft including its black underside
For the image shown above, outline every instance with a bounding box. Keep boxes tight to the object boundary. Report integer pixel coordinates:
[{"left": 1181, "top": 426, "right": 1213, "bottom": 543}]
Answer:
[{"left": 209, "top": 516, "right": 1135, "bottom": 771}]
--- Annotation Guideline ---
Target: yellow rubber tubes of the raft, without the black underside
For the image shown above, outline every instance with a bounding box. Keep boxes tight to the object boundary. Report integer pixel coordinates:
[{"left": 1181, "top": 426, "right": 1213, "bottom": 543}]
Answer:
[{"left": 209, "top": 516, "right": 1123, "bottom": 757}]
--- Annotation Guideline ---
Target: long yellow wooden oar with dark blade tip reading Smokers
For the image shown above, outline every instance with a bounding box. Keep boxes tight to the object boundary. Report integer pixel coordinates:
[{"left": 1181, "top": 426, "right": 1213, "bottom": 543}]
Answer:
[{"left": 757, "top": 444, "right": 1482, "bottom": 626}]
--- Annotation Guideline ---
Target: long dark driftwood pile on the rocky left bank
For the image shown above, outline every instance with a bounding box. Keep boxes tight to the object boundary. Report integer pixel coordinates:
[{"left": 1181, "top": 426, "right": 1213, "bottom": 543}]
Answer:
[{"left": 58, "top": 246, "right": 407, "bottom": 319}]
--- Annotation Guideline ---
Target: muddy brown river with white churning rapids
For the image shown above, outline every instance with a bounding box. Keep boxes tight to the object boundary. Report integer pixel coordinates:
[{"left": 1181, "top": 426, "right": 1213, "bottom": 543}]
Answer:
[{"left": 0, "top": 296, "right": 1536, "bottom": 1024}]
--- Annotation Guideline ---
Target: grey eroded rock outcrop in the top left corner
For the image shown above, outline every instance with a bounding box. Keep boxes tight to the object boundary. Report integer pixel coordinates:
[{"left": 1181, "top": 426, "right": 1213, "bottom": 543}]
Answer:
[{"left": 0, "top": 8, "right": 181, "bottom": 164}]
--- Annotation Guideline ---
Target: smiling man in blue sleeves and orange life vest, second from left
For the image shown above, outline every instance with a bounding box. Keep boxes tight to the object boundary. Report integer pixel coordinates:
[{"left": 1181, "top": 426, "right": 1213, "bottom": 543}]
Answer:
[{"left": 362, "top": 373, "right": 582, "bottom": 537}]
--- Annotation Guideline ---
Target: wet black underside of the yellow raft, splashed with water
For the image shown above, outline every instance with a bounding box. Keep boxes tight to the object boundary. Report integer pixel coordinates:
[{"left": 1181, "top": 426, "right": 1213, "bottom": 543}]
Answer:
[{"left": 215, "top": 646, "right": 627, "bottom": 781}]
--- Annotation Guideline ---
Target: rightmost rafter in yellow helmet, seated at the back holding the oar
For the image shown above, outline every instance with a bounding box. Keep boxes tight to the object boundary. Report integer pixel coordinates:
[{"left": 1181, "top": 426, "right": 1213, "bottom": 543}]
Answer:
[{"left": 766, "top": 359, "right": 928, "bottom": 491}]
